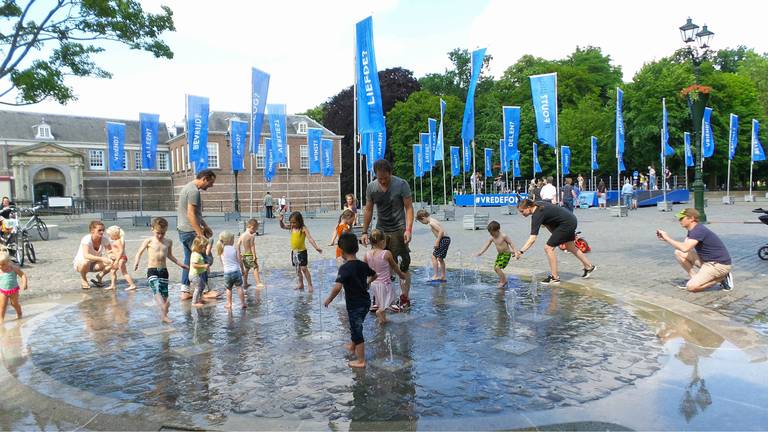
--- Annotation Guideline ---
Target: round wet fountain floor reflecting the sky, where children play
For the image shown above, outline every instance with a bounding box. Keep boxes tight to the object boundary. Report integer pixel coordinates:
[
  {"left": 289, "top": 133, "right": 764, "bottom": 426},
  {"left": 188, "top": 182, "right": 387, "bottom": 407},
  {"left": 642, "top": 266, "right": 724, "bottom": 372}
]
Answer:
[{"left": 1, "top": 262, "right": 765, "bottom": 428}]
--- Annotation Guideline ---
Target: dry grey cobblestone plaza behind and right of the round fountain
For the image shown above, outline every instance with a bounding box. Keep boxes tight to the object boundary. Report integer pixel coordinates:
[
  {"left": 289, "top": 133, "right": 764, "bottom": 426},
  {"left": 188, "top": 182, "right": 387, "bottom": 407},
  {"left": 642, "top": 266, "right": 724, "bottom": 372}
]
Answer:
[{"left": 18, "top": 197, "right": 768, "bottom": 335}]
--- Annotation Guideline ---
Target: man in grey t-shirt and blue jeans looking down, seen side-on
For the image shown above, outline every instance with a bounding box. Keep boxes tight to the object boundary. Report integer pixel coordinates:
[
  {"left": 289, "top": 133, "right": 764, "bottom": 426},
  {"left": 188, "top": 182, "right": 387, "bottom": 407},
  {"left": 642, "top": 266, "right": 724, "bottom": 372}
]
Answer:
[{"left": 176, "top": 170, "right": 216, "bottom": 299}]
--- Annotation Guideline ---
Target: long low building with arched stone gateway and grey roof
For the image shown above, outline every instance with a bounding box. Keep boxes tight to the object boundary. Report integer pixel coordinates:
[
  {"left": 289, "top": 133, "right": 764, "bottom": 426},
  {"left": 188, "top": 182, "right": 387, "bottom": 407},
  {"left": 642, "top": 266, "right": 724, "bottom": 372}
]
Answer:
[{"left": 0, "top": 111, "right": 173, "bottom": 209}]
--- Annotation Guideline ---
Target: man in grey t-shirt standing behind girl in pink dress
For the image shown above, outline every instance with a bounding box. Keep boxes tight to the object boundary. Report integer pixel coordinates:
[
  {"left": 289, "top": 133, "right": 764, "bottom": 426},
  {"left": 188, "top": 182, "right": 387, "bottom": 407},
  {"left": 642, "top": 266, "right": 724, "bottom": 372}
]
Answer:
[{"left": 360, "top": 159, "right": 413, "bottom": 307}]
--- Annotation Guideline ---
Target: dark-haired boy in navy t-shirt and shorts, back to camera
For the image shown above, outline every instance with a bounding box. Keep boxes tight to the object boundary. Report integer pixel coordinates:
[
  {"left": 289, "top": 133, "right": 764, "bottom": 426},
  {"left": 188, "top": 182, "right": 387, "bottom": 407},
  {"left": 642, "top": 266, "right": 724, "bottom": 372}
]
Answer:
[{"left": 323, "top": 233, "right": 376, "bottom": 368}]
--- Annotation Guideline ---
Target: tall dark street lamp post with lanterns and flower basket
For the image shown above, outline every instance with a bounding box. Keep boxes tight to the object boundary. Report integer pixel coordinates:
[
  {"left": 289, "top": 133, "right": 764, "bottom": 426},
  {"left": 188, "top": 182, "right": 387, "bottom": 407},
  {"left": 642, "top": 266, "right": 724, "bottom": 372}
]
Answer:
[{"left": 680, "top": 17, "right": 715, "bottom": 223}]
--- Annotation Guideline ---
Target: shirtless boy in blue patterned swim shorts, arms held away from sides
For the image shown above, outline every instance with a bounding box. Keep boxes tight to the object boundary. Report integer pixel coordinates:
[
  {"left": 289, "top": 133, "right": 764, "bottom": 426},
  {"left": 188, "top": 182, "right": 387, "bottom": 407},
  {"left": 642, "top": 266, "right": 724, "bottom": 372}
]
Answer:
[{"left": 133, "top": 217, "right": 189, "bottom": 324}]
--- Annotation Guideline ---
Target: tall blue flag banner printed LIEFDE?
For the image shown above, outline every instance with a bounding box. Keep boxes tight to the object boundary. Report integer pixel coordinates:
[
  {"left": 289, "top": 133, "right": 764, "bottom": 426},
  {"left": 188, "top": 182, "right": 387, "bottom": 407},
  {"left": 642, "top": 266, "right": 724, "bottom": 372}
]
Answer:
[{"left": 355, "top": 17, "right": 385, "bottom": 134}]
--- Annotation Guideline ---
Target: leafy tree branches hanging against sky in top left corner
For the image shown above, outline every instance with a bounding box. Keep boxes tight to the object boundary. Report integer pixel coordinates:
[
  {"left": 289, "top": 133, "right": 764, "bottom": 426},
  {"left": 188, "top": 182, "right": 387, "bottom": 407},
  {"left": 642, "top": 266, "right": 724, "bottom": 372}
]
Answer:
[{"left": 0, "top": 0, "right": 175, "bottom": 106}]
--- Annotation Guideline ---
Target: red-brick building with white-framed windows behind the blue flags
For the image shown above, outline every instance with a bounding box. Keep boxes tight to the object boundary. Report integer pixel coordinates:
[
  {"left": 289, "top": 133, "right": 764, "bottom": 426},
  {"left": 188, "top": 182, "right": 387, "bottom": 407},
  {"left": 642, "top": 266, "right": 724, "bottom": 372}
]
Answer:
[{"left": 168, "top": 112, "right": 343, "bottom": 214}]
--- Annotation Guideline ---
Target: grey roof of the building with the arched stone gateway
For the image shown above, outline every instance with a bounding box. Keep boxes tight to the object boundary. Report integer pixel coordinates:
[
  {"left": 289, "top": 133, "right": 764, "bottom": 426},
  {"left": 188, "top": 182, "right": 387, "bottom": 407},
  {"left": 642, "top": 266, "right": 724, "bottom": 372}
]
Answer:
[{"left": 0, "top": 110, "right": 170, "bottom": 144}]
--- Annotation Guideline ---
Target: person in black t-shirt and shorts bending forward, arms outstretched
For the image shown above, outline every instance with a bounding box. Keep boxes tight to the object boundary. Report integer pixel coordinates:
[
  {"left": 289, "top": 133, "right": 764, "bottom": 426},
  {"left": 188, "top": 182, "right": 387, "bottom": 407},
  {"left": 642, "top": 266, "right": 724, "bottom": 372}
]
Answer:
[{"left": 515, "top": 199, "right": 596, "bottom": 285}]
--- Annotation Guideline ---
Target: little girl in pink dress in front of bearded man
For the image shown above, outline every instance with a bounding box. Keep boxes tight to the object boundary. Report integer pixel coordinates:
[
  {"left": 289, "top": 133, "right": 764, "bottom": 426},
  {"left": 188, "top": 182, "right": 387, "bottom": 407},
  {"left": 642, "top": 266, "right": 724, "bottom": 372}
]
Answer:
[{"left": 364, "top": 229, "right": 406, "bottom": 324}]
